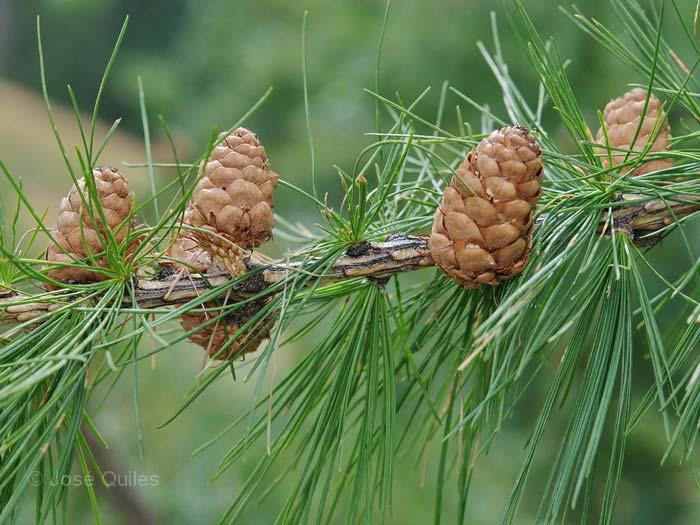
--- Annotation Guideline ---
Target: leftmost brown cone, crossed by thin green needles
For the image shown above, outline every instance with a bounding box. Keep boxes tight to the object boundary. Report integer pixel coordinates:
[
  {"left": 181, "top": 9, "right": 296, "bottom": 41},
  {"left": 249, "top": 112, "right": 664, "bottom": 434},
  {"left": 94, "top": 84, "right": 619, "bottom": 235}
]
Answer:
[{"left": 46, "top": 168, "right": 133, "bottom": 283}]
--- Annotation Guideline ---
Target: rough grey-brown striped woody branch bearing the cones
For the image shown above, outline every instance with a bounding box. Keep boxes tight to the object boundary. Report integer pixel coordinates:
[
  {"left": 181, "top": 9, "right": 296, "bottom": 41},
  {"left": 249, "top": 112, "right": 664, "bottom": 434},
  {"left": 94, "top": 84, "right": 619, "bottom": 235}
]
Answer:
[{"left": 0, "top": 194, "right": 700, "bottom": 323}]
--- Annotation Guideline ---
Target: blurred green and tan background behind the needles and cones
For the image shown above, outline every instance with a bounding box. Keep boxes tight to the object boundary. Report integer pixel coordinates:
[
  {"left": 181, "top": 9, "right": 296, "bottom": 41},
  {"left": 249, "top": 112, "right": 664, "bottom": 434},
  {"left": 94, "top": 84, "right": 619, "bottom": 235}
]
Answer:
[{"left": 0, "top": 0, "right": 700, "bottom": 524}]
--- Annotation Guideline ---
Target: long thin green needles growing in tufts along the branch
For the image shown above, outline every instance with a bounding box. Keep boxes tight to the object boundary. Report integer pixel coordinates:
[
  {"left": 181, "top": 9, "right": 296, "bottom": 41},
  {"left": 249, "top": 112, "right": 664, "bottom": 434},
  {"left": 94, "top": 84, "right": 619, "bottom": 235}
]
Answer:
[{"left": 0, "top": 0, "right": 700, "bottom": 523}]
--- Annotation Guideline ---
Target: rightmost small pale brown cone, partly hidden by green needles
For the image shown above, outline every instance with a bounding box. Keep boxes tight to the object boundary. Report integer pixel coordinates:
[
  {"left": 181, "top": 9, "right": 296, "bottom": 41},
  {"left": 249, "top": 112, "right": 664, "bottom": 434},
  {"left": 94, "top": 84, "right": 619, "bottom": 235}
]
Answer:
[{"left": 596, "top": 88, "right": 673, "bottom": 176}]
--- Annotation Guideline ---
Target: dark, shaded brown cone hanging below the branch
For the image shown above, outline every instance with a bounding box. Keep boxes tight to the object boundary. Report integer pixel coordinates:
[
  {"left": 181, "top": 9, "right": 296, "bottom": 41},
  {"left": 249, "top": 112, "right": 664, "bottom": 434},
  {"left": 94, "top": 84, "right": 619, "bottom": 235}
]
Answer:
[{"left": 180, "top": 299, "right": 274, "bottom": 361}]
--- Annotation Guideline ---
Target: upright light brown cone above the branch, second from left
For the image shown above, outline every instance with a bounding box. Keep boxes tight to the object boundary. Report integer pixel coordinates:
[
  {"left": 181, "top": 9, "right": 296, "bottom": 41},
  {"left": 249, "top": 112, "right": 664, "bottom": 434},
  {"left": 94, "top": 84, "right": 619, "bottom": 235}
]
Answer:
[{"left": 185, "top": 128, "right": 278, "bottom": 275}]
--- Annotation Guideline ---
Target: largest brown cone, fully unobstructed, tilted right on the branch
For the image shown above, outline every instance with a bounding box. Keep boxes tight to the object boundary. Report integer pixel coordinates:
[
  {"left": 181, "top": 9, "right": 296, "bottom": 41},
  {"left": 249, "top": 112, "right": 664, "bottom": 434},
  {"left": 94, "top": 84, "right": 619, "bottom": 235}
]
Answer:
[{"left": 428, "top": 127, "right": 542, "bottom": 288}]
